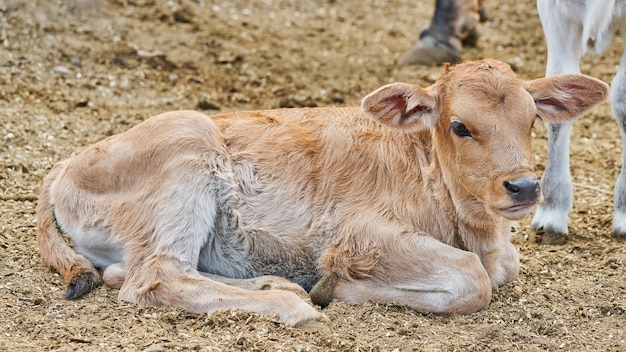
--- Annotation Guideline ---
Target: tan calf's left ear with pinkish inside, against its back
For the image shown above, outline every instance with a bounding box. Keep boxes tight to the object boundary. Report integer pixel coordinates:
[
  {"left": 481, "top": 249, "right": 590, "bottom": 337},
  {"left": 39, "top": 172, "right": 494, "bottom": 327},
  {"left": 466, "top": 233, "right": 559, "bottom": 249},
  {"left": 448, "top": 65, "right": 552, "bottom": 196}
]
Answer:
[{"left": 361, "top": 83, "right": 436, "bottom": 132}]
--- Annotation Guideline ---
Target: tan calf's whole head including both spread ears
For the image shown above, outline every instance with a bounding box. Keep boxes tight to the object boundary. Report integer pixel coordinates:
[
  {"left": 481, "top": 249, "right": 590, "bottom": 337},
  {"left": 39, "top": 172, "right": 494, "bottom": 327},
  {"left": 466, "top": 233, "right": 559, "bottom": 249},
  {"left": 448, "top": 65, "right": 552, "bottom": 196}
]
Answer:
[{"left": 361, "top": 60, "right": 608, "bottom": 220}]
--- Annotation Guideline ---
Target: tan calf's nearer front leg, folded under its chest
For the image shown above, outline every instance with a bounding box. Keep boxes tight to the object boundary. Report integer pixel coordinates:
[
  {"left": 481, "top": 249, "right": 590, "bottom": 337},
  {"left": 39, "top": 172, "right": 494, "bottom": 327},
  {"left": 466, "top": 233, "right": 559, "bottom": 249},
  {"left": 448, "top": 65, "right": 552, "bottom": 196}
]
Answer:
[{"left": 322, "top": 233, "right": 492, "bottom": 314}]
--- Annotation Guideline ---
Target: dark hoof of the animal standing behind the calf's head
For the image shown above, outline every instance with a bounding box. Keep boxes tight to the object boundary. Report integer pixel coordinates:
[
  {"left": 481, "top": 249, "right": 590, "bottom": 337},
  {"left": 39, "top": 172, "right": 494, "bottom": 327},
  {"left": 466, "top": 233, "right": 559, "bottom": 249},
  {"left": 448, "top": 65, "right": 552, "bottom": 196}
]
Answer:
[{"left": 398, "top": 36, "right": 461, "bottom": 65}]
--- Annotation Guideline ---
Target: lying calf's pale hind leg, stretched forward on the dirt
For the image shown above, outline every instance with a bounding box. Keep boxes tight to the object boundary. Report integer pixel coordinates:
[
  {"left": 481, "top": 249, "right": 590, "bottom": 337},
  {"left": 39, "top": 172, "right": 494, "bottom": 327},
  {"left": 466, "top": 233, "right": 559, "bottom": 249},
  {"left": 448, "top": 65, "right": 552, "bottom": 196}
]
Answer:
[{"left": 112, "top": 155, "right": 325, "bottom": 326}]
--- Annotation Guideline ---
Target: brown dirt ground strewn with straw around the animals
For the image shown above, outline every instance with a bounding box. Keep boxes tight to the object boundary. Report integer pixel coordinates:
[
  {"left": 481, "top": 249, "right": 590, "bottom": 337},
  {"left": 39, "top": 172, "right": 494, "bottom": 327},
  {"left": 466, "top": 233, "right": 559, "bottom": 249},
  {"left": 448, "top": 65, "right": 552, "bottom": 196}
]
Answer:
[{"left": 0, "top": 0, "right": 626, "bottom": 351}]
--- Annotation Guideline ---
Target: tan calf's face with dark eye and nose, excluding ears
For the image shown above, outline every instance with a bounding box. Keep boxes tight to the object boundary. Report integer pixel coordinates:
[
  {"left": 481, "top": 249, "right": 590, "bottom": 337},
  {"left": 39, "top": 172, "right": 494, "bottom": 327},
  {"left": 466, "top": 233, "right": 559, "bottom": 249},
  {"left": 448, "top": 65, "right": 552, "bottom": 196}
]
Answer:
[{"left": 433, "top": 63, "right": 542, "bottom": 219}]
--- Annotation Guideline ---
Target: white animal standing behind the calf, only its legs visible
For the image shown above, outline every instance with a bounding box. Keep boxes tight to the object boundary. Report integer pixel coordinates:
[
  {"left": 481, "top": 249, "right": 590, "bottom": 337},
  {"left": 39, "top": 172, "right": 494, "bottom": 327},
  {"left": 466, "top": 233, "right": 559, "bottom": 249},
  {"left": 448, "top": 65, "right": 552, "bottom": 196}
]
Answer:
[{"left": 532, "top": 0, "right": 626, "bottom": 244}]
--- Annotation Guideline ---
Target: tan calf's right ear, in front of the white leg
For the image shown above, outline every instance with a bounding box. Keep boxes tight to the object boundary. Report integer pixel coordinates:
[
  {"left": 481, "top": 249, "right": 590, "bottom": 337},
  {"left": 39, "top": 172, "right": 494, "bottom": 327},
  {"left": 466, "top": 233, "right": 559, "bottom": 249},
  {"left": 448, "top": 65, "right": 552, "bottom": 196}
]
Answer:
[{"left": 526, "top": 74, "right": 609, "bottom": 122}]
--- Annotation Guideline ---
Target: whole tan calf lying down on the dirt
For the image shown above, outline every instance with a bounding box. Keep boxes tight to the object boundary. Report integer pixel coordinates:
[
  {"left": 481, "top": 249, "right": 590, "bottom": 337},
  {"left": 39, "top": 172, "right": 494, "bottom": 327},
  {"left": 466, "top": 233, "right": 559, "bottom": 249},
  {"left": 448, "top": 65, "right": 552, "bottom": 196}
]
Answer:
[{"left": 37, "top": 60, "right": 607, "bottom": 325}]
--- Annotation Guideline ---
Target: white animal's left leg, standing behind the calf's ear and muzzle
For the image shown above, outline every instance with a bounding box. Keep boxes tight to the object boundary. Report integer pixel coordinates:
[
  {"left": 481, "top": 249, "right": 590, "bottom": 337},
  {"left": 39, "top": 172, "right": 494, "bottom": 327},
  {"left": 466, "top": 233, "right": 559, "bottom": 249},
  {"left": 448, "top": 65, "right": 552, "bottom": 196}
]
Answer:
[{"left": 532, "top": 0, "right": 582, "bottom": 244}]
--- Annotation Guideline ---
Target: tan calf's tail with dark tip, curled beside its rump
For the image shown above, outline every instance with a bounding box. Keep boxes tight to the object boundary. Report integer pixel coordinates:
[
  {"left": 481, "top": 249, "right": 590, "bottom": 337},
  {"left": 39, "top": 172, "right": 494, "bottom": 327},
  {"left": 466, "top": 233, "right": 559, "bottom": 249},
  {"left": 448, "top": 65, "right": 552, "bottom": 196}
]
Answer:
[{"left": 36, "top": 163, "right": 102, "bottom": 299}]
